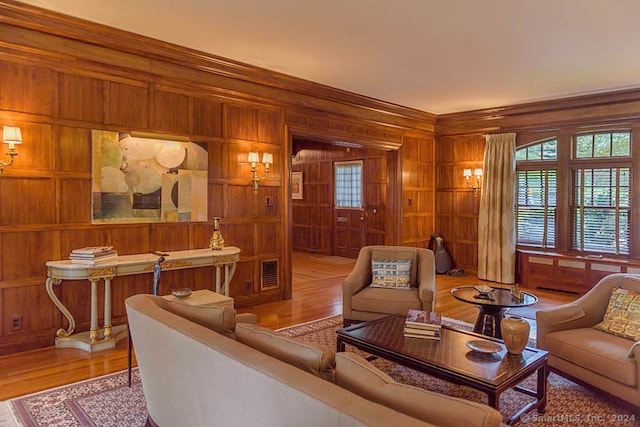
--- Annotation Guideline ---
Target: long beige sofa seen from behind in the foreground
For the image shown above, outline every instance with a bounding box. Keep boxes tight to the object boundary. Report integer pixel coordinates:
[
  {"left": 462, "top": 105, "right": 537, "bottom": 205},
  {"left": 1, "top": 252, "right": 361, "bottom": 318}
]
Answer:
[{"left": 126, "top": 295, "right": 501, "bottom": 427}]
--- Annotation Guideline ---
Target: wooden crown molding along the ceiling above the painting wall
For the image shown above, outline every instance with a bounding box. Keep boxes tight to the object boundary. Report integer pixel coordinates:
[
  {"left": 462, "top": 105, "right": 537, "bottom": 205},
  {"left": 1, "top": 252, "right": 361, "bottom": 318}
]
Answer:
[{"left": 0, "top": 0, "right": 436, "bottom": 128}]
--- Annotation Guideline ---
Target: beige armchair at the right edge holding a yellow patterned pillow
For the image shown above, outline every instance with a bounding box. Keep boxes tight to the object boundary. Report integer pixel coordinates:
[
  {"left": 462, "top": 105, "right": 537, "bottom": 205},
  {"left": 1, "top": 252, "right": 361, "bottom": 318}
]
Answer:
[{"left": 536, "top": 273, "right": 640, "bottom": 406}]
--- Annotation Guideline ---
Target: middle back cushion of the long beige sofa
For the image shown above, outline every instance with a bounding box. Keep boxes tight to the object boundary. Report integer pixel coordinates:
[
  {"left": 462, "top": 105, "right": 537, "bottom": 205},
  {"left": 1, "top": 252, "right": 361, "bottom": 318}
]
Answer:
[{"left": 236, "top": 323, "right": 335, "bottom": 382}]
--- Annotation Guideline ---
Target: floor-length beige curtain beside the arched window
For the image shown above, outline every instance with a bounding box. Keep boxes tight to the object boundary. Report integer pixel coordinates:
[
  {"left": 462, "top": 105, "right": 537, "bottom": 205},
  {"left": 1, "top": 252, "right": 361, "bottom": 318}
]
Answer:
[{"left": 478, "top": 133, "right": 516, "bottom": 283}]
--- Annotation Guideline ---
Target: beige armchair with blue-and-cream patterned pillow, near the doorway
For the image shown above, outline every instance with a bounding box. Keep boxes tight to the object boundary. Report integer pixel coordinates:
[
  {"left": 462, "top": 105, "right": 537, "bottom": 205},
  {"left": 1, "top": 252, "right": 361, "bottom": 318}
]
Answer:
[{"left": 342, "top": 246, "right": 436, "bottom": 326}]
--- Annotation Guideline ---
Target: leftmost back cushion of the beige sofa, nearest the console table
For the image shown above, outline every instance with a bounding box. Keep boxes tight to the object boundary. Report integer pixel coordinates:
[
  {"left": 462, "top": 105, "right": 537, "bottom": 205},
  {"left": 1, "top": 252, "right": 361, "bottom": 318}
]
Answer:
[{"left": 154, "top": 297, "right": 236, "bottom": 339}]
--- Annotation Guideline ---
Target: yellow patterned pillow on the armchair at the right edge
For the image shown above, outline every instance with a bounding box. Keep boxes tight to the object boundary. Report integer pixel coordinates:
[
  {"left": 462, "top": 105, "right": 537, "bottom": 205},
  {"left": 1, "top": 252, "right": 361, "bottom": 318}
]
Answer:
[{"left": 594, "top": 288, "right": 640, "bottom": 341}]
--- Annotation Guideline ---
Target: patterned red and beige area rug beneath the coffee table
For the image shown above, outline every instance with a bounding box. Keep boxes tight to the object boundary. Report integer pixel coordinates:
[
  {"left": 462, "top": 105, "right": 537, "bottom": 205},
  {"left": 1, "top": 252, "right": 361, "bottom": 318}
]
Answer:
[{"left": 6, "top": 315, "right": 640, "bottom": 427}]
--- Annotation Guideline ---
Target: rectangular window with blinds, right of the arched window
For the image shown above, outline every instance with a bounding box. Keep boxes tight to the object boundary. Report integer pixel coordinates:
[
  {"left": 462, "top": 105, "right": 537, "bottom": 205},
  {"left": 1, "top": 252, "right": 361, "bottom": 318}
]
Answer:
[{"left": 570, "top": 132, "right": 631, "bottom": 255}]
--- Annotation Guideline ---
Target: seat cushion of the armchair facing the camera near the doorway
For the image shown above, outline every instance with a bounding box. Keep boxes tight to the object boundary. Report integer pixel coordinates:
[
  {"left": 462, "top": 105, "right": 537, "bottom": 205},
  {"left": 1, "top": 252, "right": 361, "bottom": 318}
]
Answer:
[{"left": 351, "top": 286, "right": 422, "bottom": 314}]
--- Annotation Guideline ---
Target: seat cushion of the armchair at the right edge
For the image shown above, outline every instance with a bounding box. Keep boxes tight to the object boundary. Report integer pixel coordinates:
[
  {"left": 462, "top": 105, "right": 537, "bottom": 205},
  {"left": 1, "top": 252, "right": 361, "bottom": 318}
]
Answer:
[{"left": 545, "top": 328, "right": 638, "bottom": 387}]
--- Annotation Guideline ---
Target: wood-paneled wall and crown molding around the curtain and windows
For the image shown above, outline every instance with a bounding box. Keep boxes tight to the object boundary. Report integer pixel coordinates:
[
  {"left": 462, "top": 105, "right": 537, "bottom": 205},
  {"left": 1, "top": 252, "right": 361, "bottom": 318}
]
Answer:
[{"left": 436, "top": 90, "right": 640, "bottom": 276}]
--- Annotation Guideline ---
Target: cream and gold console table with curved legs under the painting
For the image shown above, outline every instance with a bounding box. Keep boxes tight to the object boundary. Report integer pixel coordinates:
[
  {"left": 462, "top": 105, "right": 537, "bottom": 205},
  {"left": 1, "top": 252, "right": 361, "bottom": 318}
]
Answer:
[{"left": 45, "top": 246, "right": 240, "bottom": 352}]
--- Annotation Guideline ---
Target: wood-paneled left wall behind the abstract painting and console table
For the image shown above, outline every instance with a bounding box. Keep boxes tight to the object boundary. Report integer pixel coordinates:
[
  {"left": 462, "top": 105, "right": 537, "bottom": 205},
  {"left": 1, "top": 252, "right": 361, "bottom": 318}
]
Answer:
[{"left": 0, "top": 0, "right": 435, "bottom": 354}]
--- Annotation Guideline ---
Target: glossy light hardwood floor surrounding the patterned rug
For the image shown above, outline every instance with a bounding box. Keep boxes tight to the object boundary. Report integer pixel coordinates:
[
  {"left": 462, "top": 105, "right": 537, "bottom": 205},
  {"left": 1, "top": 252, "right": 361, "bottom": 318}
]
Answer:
[{"left": 0, "top": 252, "right": 576, "bottom": 401}]
